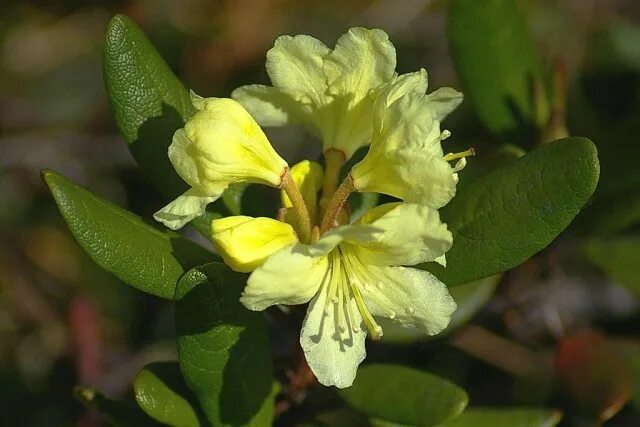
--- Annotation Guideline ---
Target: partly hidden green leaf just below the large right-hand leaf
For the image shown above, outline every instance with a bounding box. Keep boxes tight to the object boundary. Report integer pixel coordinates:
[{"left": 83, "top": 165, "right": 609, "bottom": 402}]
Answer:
[{"left": 377, "top": 275, "right": 502, "bottom": 344}]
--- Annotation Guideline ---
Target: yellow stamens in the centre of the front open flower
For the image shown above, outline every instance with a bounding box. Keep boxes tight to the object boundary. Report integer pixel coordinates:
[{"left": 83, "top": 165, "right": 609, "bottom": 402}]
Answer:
[{"left": 324, "top": 247, "right": 382, "bottom": 340}]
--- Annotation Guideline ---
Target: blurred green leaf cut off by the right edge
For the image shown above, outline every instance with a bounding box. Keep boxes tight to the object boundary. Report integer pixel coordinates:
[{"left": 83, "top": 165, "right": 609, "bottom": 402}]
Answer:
[{"left": 583, "top": 237, "right": 640, "bottom": 298}]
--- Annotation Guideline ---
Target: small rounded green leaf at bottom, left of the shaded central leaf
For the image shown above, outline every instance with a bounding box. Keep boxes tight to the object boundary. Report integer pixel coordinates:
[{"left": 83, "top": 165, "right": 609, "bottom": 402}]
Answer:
[{"left": 133, "top": 362, "right": 200, "bottom": 427}]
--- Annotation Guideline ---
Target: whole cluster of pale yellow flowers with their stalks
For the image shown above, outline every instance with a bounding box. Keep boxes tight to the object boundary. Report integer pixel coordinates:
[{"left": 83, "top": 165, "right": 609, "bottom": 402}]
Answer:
[{"left": 155, "top": 28, "right": 473, "bottom": 387}]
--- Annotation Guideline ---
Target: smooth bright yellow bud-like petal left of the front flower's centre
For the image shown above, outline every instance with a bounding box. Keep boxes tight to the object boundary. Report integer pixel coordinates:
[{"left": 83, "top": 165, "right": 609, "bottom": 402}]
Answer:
[{"left": 211, "top": 216, "right": 298, "bottom": 273}]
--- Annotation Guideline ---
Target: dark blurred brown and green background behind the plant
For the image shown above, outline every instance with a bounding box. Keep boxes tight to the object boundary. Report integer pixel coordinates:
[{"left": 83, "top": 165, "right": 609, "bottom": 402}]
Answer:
[{"left": 0, "top": 0, "right": 640, "bottom": 426}]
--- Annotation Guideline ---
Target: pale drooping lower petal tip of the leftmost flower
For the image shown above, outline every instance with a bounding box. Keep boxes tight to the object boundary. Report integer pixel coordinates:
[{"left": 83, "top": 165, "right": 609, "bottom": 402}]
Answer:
[{"left": 153, "top": 188, "right": 224, "bottom": 230}]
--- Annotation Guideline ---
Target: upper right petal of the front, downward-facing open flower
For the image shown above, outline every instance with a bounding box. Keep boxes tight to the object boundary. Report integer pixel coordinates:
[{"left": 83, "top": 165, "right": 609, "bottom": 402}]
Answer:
[{"left": 351, "top": 203, "right": 453, "bottom": 266}]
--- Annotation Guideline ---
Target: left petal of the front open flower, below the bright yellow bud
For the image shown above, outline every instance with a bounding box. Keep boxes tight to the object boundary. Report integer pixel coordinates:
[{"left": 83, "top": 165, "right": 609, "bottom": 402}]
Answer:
[{"left": 240, "top": 245, "right": 329, "bottom": 311}]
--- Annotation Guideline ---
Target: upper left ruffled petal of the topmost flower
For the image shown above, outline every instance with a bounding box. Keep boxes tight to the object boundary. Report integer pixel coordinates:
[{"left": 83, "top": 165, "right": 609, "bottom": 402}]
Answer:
[{"left": 266, "top": 35, "right": 330, "bottom": 105}]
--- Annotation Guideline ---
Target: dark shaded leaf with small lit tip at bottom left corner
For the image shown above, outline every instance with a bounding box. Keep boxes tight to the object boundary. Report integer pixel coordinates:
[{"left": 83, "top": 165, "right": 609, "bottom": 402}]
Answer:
[{"left": 73, "top": 387, "right": 161, "bottom": 427}]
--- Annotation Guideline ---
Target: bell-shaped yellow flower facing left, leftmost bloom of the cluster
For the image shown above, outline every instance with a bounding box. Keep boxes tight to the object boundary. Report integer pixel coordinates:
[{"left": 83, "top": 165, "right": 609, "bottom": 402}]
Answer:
[{"left": 154, "top": 95, "right": 288, "bottom": 230}]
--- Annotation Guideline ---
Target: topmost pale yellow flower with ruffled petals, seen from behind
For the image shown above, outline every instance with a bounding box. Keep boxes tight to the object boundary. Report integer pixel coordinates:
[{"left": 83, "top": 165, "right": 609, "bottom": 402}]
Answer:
[{"left": 232, "top": 28, "right": 396, "bottom": 158}]
